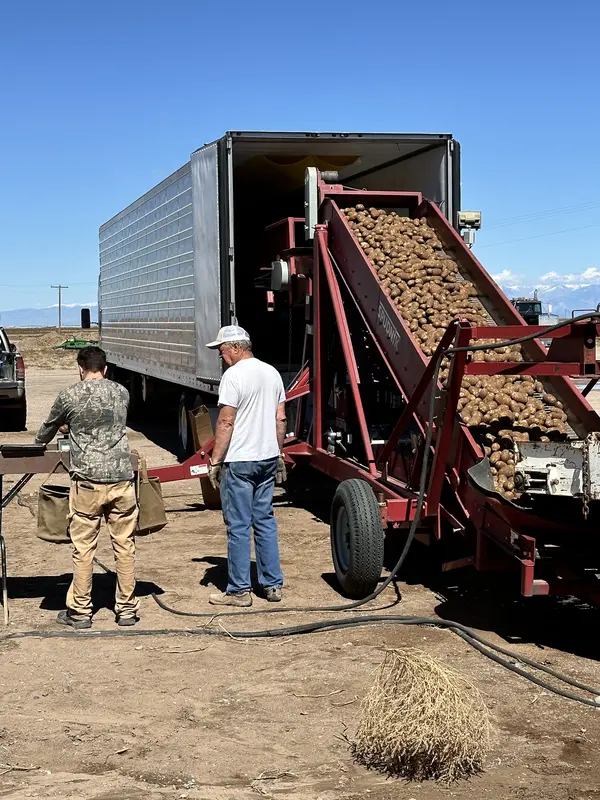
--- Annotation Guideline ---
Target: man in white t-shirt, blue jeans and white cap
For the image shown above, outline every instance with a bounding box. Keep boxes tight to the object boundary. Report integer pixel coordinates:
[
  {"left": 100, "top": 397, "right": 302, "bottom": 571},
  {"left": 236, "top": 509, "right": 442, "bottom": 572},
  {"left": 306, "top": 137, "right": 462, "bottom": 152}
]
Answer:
[{"left": 206, "top": 325, "right": 286, "bottom": 607}]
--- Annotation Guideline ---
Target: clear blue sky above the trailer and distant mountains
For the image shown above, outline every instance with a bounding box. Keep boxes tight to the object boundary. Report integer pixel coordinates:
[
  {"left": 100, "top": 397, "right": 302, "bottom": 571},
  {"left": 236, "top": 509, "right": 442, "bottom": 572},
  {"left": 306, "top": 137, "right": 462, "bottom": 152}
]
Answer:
[{"left": 0, "top": 0, "right": 600, "bottom": 310}]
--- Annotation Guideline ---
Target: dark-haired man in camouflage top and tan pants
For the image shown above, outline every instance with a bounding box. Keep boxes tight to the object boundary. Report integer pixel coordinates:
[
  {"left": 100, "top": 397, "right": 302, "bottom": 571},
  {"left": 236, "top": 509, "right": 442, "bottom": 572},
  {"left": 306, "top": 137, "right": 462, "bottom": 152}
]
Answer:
[{"left": 36, "top": 347, "right": 139, "bottom": 628}]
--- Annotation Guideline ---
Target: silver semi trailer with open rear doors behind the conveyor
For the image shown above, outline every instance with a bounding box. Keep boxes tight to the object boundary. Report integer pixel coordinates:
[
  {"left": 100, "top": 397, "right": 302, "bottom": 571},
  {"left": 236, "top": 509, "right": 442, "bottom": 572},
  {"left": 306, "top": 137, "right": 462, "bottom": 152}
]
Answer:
[{"left": 98, "top": 131, "right": 460, "bottom": 454}]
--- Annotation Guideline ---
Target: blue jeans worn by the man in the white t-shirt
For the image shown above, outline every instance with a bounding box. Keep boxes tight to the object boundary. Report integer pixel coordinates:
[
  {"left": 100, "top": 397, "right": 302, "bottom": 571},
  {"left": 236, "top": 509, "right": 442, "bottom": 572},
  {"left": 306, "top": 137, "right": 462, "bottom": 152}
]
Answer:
[{"left": 221, "top": 458, "right": 283, "bottom": 594}]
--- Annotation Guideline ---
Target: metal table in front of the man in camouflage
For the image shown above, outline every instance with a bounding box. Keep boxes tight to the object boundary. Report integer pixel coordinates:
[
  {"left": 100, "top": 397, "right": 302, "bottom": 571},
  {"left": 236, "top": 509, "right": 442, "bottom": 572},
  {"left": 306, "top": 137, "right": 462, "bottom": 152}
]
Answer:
[{"left": 0, "top": 444, "right": 69, "bottom": 625}]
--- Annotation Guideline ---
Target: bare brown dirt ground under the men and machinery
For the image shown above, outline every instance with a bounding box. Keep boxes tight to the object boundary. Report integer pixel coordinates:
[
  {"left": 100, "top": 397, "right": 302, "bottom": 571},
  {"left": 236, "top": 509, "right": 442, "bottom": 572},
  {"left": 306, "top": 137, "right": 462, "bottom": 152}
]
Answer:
[{"left": 0, "top": 358, "right": 600, "bottom": 800}]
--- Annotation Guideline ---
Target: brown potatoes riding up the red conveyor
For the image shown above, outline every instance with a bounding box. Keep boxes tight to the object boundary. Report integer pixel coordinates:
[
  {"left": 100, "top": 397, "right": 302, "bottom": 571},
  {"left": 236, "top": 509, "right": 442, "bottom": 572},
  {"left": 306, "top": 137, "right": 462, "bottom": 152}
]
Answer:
[{"left": 344, "top": 204, "right": 567, "bottom": 500}]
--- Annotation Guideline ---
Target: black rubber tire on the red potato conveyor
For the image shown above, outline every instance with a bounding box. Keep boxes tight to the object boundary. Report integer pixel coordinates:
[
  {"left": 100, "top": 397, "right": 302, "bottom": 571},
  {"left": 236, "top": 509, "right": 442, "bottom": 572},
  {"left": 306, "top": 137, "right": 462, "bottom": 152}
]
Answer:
[{"left": 331, "top": 478, "right": 384, "bottom": 598}]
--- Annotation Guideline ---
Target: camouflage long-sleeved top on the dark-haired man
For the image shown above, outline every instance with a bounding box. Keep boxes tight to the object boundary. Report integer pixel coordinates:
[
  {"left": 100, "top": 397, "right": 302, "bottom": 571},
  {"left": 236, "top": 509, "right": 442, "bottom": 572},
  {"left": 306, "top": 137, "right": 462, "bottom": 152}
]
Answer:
[{"left": 36, "top": 378, "right": 133, "bottom": 483}]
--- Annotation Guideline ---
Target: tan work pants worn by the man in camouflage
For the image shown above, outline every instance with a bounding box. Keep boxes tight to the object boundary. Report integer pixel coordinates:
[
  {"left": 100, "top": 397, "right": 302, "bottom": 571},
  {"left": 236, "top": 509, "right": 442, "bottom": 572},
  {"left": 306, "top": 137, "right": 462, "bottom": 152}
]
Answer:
[{"left": 67, "top": 480, "right": 139, "bottom": 618}]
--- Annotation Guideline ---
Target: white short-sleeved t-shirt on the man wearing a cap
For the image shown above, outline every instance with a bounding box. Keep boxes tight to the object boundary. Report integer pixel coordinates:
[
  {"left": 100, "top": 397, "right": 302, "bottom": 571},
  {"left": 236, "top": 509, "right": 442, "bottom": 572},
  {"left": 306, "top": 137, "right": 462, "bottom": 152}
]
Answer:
[{"left": 219, "top": 358, "right": 285, "bottom": 463}]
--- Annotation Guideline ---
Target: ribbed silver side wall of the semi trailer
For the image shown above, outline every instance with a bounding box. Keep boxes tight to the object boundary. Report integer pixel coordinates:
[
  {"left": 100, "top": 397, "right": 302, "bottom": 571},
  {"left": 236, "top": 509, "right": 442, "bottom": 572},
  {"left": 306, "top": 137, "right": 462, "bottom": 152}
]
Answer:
[{"left": 99, "top": 159, "right": 220, "bottom": 390}]
